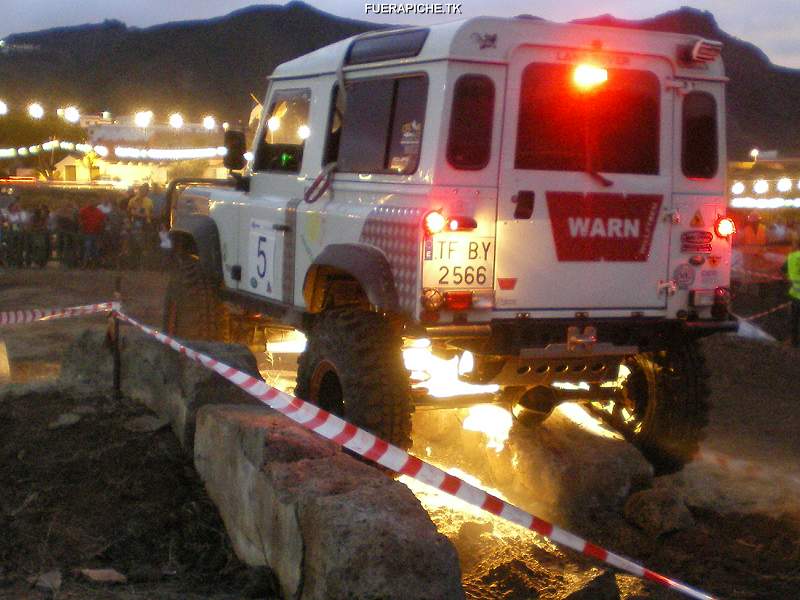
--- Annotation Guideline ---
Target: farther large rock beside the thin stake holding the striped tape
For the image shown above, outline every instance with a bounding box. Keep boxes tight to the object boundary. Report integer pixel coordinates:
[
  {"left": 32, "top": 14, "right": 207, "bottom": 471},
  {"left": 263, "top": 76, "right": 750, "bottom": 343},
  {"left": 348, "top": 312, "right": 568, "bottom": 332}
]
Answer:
[{"left": 61, "top": 329, "right": 259, "bottom": 452}]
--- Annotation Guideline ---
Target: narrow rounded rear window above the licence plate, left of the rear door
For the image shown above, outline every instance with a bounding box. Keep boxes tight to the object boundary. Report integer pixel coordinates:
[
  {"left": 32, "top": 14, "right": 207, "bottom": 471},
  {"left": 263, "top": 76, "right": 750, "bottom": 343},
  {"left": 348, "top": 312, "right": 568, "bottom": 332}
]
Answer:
[{"left": 447, "top": 75, "right": 494, "bottom": 170}]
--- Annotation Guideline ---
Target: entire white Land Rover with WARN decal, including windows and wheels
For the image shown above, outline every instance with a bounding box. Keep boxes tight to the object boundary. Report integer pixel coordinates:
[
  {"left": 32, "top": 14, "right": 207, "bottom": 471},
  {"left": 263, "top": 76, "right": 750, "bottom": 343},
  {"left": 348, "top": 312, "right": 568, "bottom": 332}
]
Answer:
[{"left": 165, "top": 18, "right": 736, "bottom": 472}]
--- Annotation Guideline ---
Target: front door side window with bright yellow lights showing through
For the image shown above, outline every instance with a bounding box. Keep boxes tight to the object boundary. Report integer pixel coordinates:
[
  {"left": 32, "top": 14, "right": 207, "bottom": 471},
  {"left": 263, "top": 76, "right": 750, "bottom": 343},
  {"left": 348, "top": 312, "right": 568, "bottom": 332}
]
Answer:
[{"left": 255, "top": 90, "right": 311, "bottom": 173}]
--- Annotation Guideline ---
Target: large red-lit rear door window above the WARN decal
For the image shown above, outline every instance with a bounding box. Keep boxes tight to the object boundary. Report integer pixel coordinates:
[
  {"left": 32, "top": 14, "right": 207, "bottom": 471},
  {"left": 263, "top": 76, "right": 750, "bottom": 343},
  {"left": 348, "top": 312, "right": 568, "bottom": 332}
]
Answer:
[{"left": 515, "top": 63, "right": 660, "bottom": 175}]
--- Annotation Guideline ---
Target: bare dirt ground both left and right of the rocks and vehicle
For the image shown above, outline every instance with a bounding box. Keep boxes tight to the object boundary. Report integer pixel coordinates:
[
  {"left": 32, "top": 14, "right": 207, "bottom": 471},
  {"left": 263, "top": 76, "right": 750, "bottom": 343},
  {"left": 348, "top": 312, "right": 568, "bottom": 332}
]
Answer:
[{"left": 0, "top": 269, "right": 800, "bottom": 600}]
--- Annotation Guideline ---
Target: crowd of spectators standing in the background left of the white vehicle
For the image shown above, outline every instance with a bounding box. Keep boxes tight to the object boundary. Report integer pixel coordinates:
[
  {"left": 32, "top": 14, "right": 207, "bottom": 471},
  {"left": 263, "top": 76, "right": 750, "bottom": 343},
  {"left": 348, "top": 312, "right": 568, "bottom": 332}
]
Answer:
[{"left": 0, "top": 184, "right": 170, "bottom": 269}]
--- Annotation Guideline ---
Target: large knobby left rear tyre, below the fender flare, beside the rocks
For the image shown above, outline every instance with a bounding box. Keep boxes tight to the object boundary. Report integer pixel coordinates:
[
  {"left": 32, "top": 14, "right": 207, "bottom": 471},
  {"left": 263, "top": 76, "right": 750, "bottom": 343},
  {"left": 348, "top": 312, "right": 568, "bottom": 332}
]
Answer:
[{"left": 295, "top": 308, "right": 412, "bottom": 448}]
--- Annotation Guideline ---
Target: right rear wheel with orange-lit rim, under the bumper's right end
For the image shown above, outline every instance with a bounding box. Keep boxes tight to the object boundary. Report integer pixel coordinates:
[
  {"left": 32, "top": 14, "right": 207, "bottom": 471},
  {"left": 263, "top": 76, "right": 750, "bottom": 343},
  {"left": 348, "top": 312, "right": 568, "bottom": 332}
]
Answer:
[{"left": 598, "top": 341, "right": 709, "bottom": 475}]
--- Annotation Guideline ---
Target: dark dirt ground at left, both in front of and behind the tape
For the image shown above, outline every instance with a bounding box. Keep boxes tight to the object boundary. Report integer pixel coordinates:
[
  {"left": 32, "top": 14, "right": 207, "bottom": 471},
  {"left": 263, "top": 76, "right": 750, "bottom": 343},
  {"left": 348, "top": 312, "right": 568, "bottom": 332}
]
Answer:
[{"left": 0, "top": 269, "right": 278, "bottom": 600}]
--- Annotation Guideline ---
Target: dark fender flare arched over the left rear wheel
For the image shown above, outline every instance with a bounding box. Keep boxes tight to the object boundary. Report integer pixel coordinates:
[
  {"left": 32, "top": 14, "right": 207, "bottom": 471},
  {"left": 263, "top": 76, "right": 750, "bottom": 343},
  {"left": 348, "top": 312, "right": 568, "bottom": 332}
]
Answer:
[{"left": 303, "top": 244, "right": 400, "bottom": 312}]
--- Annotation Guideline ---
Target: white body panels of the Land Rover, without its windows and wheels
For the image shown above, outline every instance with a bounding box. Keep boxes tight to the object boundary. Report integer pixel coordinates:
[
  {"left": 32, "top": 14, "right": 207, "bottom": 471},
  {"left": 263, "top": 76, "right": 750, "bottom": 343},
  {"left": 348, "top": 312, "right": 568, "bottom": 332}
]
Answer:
[{"left": 177, "top": 18, "right": 731, "bottom": 332}]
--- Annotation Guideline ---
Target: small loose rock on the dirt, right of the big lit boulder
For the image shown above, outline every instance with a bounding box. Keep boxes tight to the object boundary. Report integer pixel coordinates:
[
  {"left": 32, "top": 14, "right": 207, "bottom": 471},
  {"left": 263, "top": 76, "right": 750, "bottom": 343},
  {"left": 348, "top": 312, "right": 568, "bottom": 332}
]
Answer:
[{"left": 624, "top": 486, "right": 694, "bottom": 537}]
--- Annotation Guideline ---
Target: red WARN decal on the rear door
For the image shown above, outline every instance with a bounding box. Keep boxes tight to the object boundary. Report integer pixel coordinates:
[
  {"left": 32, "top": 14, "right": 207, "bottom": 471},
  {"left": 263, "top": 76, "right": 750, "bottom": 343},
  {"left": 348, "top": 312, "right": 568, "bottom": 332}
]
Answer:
[{"left": 547, "top": 192, "right": 662, "bottom": 262}]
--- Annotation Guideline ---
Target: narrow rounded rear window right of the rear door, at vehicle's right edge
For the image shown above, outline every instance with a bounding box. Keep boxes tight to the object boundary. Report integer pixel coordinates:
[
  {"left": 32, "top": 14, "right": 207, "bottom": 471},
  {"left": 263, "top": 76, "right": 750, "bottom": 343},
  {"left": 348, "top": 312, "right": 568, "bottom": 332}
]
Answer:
[{"left": 681, "top": 92, "right": 719, "bottom": 179}]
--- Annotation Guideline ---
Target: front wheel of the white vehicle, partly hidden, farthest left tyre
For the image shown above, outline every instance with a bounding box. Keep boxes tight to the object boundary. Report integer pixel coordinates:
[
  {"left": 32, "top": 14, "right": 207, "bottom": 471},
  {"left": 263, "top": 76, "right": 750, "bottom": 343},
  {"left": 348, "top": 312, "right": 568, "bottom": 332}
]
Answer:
[{"left": 164, "top": 257, "right": 227, "bottom": 341}]
